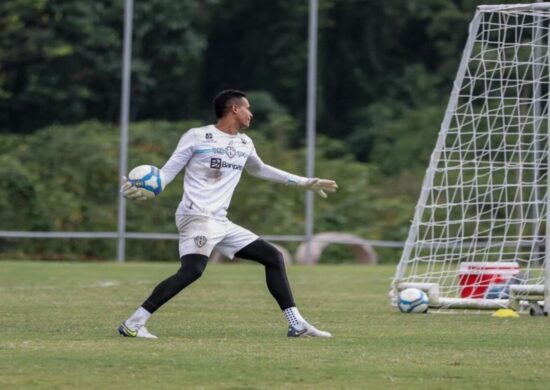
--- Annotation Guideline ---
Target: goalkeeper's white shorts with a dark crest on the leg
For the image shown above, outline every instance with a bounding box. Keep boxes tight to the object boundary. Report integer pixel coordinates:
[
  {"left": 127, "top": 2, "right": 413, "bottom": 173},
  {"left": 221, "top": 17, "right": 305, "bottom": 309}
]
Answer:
[{"left": 176, "top": 215, "right": 258, "bottom": 259}]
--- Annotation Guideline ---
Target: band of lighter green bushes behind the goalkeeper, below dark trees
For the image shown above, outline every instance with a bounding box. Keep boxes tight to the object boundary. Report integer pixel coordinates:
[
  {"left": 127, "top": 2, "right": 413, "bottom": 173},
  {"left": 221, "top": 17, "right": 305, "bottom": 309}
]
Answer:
[{"left": 0, "top": 120, "right": 414, "bottom": 260}]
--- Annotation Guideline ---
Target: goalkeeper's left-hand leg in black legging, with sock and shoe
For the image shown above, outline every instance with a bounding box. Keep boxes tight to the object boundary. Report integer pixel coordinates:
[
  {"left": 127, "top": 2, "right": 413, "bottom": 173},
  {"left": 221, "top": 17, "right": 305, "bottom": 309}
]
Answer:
[{"left": 118, "top": 254, "right": 208, "bottom": 338}]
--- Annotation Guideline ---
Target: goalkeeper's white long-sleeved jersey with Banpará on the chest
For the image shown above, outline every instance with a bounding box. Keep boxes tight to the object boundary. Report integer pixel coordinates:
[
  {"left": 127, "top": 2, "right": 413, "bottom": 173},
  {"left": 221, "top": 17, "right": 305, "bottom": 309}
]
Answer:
[{"left": 161, "top": 125, "right": 307, "bottom": 219}]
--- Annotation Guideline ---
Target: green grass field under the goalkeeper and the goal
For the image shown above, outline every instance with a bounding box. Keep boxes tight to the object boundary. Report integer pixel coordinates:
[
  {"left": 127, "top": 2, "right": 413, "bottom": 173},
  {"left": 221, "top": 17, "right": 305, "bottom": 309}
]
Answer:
[{"left": 0, "top": 262, "right": 550, "bottom": 389}]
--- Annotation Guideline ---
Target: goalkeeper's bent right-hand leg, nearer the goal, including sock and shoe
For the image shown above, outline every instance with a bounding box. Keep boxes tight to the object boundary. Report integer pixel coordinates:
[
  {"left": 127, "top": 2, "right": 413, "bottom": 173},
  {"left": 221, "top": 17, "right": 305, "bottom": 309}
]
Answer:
[{"left": 235, "top": 239, "right": 332, "bottom": 337}]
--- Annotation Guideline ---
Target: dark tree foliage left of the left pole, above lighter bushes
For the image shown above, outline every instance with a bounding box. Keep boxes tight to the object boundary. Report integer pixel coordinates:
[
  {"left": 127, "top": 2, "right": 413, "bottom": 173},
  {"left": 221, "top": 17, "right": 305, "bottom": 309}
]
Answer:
[{"left": 0, "top": 0, "right": 122, "bottom": 132}]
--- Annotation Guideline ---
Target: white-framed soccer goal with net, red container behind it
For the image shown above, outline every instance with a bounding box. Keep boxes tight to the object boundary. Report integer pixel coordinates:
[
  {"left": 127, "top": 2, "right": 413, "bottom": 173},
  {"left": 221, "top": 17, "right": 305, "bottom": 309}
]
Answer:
[{"left": 390, "top": 3, "right": 550, "bottom": 314}]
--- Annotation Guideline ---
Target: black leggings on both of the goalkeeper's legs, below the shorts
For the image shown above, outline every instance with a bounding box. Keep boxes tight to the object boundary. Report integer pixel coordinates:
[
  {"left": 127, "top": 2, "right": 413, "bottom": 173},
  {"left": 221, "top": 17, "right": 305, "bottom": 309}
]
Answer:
[{"left": 141, "top": 239, "right": 296, "bottom": 313}]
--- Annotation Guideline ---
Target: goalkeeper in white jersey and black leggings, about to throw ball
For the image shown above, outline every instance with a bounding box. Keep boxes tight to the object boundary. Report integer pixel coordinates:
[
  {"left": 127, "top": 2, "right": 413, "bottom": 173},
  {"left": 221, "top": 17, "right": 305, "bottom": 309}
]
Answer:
[{"left": 118, "top": 90, "right": 338, "bottom": 338}]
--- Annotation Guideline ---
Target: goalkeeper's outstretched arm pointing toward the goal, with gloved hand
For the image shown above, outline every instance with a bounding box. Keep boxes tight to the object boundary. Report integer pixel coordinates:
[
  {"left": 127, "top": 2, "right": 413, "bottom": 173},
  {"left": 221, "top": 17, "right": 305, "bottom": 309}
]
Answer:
[{"left": 245, "top": 149, "right": 338, "bottom": 198}]
